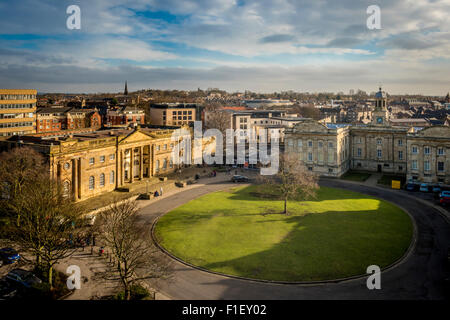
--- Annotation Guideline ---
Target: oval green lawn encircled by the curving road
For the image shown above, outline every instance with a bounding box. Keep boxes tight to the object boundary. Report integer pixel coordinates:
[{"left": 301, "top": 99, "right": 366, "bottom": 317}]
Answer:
[{"left": 155, "top": 186, "right": 412, "bottom": 281}]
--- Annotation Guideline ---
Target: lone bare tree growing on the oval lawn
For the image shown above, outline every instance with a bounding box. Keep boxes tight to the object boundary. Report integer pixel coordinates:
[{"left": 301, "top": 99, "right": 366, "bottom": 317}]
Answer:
[{"left": 267, "top": 153, "right": 319, "bottom": 215}]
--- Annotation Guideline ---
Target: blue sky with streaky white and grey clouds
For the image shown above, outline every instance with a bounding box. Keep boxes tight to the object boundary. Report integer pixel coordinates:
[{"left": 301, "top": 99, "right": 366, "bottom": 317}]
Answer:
[{"left": 0, "top": 0, "right": 450, "bottom": 96}]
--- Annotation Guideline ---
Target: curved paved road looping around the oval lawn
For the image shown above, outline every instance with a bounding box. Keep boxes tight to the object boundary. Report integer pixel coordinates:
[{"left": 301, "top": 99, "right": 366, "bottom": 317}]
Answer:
[{"left": 140, "top": 179, "right": 450, "bottom": 300}]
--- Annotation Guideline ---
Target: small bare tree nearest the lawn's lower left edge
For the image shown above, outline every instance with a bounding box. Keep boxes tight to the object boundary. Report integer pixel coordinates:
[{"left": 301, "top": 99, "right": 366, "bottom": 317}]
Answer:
[{"left": 98, "top": 200, "right": 168, "bottom": 300}]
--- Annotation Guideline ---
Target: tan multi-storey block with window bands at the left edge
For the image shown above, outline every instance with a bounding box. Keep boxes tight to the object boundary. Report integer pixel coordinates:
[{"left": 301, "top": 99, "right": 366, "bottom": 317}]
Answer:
[{"left": 0, "top": 89, "right": 37, "bottom": 136}]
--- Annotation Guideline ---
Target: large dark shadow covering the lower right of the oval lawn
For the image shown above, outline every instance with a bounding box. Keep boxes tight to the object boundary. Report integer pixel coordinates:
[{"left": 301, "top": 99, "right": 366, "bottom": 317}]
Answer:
[{"left": 202, "top": 210, "right": 411, "bottom": 281}]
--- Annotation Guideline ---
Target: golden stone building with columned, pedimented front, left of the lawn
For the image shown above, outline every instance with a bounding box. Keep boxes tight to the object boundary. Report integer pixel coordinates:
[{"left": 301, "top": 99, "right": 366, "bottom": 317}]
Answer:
[{"left": 1, "top": 128, "right": 205, "bottom": 201}]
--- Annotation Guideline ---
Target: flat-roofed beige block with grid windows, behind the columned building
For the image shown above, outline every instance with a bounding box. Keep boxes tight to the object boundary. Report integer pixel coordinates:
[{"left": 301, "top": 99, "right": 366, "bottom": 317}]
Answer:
[{"left": 150, "top": 103, "right": 197, "bottom": 126}]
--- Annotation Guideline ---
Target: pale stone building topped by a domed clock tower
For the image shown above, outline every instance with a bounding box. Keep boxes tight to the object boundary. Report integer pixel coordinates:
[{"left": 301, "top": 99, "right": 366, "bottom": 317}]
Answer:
[{"left": 285, "top": 88, "right": 450, "bottom": 184}]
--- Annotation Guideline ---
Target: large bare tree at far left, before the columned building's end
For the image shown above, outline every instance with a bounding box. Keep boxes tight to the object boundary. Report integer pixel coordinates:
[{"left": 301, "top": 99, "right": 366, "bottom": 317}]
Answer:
[{"left": 10, "top": 172, "right": 83, "bottom": 288}]
